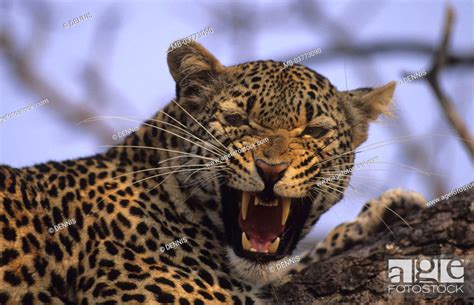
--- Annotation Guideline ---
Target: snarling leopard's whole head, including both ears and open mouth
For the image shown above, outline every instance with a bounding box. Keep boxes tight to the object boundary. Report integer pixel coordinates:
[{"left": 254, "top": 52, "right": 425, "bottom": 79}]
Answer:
[{"left": 168, "top": 42, "right": 395, "bottom": 278}]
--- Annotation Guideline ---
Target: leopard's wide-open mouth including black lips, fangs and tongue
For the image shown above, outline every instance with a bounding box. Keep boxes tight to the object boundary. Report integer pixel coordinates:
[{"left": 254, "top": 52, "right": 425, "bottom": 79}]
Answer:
[{"left": 221, "top": 186, "right": 311, "bottom": 263}]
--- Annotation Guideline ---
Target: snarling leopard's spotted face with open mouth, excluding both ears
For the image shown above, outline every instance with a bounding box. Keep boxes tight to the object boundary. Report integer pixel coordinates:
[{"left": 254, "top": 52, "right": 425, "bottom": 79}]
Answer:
[{"left": 205, "top": 61, "right": 353, "bottom": 262}]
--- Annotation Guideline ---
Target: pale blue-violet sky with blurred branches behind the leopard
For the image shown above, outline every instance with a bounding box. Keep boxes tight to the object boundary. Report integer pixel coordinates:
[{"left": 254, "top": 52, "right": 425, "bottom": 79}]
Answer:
[{"left": 0, "top": 0, "right": 474, "bottom": 243}]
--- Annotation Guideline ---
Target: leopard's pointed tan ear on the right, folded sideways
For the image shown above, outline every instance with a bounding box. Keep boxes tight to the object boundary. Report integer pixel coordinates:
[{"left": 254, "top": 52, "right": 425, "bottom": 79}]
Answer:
[{"left": 341, "top": 81, "right": 395, "bottom": 148}]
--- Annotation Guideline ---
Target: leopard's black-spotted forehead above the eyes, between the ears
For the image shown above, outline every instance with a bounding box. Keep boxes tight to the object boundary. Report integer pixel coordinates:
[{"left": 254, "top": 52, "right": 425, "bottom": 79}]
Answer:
[{"left": 219, "top": 61, "right": 337, "bottom": 129}]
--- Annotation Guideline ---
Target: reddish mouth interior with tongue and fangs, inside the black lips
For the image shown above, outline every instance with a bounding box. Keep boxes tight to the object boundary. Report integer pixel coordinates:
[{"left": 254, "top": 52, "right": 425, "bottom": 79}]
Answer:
[{"left": 239, "top": 192, "right": 289, "bottom": 253}]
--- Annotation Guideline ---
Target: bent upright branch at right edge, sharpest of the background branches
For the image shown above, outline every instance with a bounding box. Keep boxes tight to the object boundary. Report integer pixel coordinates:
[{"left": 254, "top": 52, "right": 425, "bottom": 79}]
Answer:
[{"left": 426, "top": 7, "right": 474, "bottom": 158}]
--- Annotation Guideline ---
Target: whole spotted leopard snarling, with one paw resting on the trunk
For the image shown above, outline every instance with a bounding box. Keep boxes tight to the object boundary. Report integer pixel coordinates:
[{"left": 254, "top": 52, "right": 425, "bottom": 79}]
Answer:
[{"left": 0, "top": 41, "right": 425, "bottom": 305}]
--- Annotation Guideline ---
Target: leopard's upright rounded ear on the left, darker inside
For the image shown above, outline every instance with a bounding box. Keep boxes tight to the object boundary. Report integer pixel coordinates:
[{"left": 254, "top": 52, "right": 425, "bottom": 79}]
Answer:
[{"left": 167, "top": 41, "right": 224, "bottom": 111}]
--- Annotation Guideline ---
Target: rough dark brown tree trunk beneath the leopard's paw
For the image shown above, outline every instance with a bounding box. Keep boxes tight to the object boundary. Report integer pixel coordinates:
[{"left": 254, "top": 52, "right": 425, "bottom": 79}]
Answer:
[{"left": 269, "top": 188, "right": 474, "bottom": 305}]
